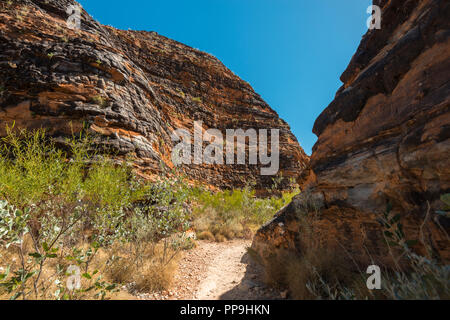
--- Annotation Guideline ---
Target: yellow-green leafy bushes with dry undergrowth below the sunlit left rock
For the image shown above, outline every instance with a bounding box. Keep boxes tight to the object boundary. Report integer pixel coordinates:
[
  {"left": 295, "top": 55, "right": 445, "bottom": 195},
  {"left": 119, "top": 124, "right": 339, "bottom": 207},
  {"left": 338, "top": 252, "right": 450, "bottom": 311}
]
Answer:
[{"left": 0, "top": 130, "right": 189, "bottom": 299}]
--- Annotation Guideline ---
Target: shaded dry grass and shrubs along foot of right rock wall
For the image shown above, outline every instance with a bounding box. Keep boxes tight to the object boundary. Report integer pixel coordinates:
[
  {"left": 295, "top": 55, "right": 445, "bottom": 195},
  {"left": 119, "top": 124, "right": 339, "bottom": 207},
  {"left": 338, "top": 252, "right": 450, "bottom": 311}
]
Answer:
[{"left": 253, "top": 194, "right": 450, "bottom": 300}]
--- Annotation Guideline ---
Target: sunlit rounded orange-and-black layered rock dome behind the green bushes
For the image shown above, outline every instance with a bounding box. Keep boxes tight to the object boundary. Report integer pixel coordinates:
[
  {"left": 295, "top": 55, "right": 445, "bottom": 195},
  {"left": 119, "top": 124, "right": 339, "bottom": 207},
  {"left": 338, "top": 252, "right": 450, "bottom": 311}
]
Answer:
[{"left": 0, "top": 0, "right": 309, "bottom": 188}]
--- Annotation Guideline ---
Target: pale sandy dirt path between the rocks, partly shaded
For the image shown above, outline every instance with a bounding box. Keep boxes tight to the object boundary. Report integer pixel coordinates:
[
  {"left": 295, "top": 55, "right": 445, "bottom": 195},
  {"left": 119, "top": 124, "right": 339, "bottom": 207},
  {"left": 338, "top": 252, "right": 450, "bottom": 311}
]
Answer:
[{"left": 168, "top": 240, "right": 281, "bottom": 300}]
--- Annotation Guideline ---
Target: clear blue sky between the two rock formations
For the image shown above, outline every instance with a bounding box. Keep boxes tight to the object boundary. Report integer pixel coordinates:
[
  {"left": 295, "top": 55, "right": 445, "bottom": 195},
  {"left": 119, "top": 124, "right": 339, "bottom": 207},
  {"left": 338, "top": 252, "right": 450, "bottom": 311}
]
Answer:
[{"left": 79, "top": 0, "right": 372, "bottom": 154}]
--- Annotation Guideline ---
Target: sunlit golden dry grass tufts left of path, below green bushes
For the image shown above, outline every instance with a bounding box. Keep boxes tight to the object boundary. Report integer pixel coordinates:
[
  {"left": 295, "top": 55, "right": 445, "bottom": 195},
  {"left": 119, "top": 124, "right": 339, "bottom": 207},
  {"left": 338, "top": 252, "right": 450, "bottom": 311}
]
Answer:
[{"left": 0, "top": 236, "right": 178, "bottom": 300}]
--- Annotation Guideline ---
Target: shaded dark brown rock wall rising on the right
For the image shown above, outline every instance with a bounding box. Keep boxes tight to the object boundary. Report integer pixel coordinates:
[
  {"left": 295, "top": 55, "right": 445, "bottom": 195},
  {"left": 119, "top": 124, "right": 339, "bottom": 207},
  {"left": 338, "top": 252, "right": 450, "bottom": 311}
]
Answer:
[{"left": 254, "top": 0, "right": 450, "bottom": 261}]
